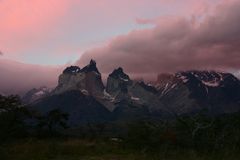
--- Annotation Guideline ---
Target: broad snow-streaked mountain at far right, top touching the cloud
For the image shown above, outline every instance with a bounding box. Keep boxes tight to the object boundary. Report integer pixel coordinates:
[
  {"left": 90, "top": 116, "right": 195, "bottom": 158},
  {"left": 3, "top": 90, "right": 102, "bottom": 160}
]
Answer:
[{"left": 155, "top": 71, "right": 240, "bottom": 114}]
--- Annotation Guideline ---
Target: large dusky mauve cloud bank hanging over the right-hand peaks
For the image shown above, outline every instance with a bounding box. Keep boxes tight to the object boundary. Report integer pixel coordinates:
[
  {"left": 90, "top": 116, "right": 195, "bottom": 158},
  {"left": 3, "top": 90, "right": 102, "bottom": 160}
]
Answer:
[{"left": 77, "top": 1, "right": 240, "bottom": 79}]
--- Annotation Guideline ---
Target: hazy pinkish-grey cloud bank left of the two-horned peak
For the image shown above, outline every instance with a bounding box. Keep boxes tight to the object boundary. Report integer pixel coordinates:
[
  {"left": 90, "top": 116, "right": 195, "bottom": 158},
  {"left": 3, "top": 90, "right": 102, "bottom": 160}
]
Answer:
[{"left": 0, "top": 59, "right": 63, "bottom": 94}]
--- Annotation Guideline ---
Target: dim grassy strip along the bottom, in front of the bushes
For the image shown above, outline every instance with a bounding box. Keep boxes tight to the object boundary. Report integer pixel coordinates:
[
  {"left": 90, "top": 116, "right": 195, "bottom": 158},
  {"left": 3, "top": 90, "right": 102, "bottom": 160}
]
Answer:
[{"left": 0, "top": 138, "right": 240, "bottom": 160}]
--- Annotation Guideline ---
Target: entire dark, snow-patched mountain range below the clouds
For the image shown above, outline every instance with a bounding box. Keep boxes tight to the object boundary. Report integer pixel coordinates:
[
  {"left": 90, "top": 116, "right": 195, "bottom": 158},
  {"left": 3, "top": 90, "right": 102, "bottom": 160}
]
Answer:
[{"left": 22, "top": 60, "right": 240, "bottom": 126}]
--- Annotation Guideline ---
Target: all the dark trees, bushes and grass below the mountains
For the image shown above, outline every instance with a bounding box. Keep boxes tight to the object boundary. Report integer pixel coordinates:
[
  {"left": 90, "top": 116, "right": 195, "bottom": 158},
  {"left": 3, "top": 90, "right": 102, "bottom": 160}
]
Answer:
[{"left": 0, "top": 96, "right": 240, "bottom": 160}]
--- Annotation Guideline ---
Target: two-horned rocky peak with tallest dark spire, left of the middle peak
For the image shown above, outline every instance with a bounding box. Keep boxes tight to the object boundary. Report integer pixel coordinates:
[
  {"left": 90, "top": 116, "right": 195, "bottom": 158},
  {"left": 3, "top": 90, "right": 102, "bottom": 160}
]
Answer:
[{"left": 52, "top": 60, "right": 104, "bottom": 97}]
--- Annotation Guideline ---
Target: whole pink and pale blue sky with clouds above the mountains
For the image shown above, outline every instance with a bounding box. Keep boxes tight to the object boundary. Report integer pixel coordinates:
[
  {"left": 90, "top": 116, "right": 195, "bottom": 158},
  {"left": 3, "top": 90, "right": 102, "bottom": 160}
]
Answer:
[{"left": 0, "top": 0, "right": 240, "bottom": 92}]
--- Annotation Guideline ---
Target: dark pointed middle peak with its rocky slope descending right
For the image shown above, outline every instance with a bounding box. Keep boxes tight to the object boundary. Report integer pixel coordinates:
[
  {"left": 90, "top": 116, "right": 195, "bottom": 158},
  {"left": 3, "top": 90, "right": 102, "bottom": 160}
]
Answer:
[{"left": 106, "top": 68, "right": 166, "bottom": 113}]
